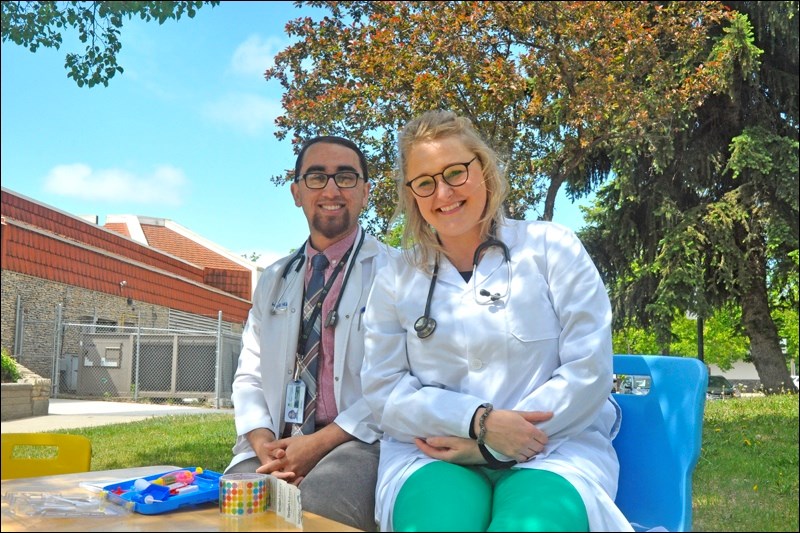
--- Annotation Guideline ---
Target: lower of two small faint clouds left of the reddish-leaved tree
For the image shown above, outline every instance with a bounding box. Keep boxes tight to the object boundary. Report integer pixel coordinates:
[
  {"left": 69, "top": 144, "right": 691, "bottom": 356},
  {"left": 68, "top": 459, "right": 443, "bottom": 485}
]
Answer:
[{"left": 203, "top": 93, "right": 281, "bottom": 135}]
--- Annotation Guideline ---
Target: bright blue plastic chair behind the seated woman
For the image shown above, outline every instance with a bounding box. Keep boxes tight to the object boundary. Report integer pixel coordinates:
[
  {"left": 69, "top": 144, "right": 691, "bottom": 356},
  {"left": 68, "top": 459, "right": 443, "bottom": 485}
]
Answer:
[{"left": 613, "top": 355, "right": 708, "bottom": 531}]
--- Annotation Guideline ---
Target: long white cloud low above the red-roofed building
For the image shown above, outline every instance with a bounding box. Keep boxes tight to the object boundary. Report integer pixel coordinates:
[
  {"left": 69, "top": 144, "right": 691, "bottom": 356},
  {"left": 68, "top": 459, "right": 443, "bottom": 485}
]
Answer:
[{"left": 44, "top": 163, "right": 187, "bottom": 205}]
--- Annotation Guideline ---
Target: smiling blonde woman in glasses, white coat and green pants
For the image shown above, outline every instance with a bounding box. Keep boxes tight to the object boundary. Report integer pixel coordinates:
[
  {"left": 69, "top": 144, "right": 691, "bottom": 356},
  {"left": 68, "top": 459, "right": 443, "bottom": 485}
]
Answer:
[{"left": 361, "top": 111, "right": 632, "bottom": 531}]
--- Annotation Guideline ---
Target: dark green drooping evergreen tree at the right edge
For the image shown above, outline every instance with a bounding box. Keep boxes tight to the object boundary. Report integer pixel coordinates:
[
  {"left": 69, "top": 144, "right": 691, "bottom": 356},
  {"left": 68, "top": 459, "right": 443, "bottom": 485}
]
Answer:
[{"left": 582, "top": 2, "right": 798, "bottom": 392}]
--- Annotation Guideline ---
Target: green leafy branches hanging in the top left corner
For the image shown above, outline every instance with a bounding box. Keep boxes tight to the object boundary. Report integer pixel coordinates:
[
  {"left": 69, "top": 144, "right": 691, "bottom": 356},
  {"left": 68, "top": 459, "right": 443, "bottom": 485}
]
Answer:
[{"left": 2, "top": 1, "right": 219, "bottom": 87}]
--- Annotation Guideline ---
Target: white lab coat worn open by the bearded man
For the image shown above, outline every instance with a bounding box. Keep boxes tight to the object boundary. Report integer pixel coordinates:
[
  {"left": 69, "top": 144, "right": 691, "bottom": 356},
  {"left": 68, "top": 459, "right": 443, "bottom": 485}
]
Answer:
[{"left": 226, "top": 229, "right": 386, "bottom": 470}]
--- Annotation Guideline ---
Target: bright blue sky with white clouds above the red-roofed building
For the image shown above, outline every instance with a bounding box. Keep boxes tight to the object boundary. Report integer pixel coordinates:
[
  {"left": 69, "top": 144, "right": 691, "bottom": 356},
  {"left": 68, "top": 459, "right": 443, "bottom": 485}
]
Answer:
[{"left": 0, "top": 1, "right": 583, "bottom": 264}]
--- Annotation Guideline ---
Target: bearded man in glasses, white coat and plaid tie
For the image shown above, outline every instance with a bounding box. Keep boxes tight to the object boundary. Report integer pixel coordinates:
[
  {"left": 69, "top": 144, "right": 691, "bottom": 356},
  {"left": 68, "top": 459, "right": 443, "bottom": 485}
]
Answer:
[{"left": 226, "top": 136, "right": 385, "bottom": 531}]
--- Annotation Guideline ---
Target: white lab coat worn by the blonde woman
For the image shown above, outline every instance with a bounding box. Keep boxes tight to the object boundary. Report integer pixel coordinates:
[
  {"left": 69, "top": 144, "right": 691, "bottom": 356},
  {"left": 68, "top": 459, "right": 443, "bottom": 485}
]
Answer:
[{"left": 362, "top": 220, "right": 632, "bottom": 531}]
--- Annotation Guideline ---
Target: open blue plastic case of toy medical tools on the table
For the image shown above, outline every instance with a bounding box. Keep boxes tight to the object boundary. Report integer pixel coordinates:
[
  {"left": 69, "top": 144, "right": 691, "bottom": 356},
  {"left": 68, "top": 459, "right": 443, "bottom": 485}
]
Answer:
[{"left": 103, "top": 466, "right": 222, "bottom": 514}]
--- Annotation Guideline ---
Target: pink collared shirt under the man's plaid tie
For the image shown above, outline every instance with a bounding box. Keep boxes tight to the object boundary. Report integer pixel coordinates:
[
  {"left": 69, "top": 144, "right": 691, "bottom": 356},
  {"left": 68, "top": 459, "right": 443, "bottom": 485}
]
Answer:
[{"left": 305, "top": 227, "right": 358, "bottom": 427}]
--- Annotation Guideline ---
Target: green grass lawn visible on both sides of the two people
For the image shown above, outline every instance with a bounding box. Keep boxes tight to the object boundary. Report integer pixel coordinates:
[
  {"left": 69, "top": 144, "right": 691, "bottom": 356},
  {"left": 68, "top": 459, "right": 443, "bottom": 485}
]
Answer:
[{"left": 53, "top": 394, "right": 800, "bottom": 531}]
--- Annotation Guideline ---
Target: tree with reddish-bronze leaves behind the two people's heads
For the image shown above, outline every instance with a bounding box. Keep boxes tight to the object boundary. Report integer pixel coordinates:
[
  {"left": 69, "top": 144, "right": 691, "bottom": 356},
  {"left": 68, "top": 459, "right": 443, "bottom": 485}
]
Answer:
[{"left": 265, "top": 2, "right": 729, "bottom": 232}]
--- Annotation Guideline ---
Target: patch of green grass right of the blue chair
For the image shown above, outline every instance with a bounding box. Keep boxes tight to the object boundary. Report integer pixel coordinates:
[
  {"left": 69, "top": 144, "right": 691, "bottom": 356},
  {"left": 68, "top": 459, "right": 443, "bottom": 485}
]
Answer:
[{"left": 692, "top": 394, "right": 800, "bottom": 531}]
